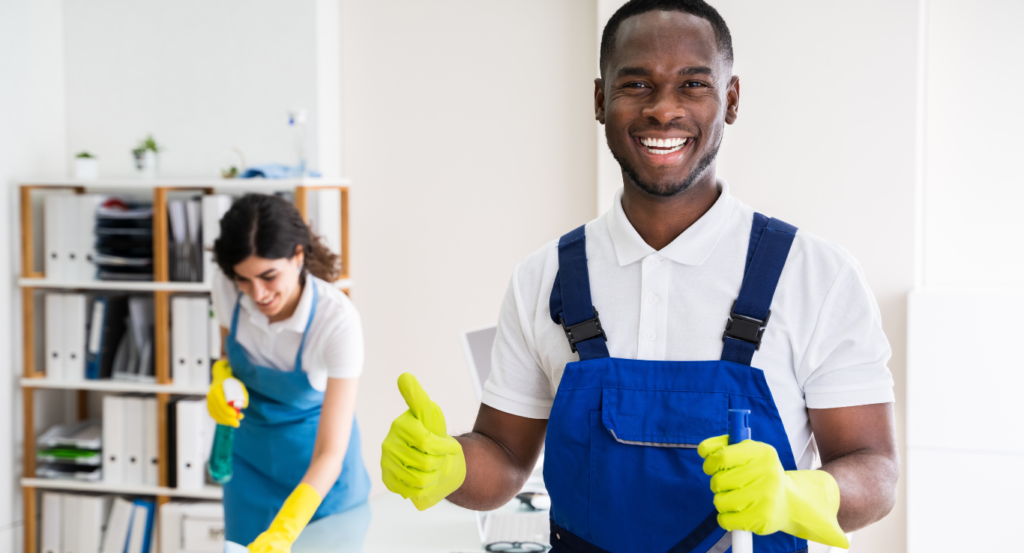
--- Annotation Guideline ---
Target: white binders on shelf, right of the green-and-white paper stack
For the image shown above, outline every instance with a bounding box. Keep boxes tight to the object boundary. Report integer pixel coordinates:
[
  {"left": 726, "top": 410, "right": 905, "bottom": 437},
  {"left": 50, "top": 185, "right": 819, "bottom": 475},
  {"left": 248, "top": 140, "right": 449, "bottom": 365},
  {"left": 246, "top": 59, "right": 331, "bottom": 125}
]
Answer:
[{"left": 103, "top": 395, "right": 160, "bottom": 485}]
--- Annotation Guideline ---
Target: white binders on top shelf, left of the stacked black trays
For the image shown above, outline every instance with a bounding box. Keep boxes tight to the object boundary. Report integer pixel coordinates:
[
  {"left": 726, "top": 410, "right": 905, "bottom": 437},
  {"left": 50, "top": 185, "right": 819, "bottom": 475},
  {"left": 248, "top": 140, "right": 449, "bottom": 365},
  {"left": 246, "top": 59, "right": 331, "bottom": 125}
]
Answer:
[{"left": 43, "top": 194, "right": 102, "bottom": 281}]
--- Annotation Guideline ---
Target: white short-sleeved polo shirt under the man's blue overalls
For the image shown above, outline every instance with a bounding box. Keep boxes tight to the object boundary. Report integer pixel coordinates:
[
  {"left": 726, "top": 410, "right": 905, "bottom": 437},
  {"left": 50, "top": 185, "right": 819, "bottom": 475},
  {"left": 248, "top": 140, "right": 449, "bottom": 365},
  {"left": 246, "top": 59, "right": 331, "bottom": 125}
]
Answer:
[{"left": 482, "top": 180, "right": 895, "bottom": 469}]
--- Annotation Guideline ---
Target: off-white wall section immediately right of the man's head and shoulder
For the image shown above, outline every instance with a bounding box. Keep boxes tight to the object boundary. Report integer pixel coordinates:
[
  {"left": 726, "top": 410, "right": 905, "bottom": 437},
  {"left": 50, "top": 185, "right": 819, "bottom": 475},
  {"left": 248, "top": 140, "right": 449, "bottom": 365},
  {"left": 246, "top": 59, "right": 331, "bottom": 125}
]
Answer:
[{"left": 714, "top": 0, "right": 918, "bottom": 553}]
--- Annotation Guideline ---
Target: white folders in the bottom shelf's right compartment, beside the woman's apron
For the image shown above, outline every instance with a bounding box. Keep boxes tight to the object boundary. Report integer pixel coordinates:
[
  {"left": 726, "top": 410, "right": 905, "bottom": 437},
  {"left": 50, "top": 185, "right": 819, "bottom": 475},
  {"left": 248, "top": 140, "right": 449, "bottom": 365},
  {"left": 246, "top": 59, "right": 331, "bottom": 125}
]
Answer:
[{"left": 159, "top": 501, "right": 224, "bottom": 553}]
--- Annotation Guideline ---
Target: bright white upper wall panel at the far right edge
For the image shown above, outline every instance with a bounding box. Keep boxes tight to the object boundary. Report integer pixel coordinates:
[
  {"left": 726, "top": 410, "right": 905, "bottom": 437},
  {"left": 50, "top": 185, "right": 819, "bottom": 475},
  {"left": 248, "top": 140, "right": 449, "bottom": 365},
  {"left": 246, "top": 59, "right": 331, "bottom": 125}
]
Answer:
[{"left": 924, "top": 0, "right": 1024, "bottom": 287}]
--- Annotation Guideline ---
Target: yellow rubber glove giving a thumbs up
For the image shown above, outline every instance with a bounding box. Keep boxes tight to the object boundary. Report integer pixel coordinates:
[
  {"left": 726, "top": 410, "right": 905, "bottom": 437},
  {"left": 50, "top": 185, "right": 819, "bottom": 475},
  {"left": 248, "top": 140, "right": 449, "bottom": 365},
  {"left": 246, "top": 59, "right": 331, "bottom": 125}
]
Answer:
[{"left": 381, "top": 373, "right": 466, "bottom": 511}]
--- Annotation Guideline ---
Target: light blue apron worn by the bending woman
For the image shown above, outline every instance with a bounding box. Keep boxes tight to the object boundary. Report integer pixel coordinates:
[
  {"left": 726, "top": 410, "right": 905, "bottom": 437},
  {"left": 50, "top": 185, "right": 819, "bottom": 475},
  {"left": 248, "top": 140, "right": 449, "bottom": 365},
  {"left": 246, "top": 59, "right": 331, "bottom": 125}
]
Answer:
[{"left": 224, "top": 279, "right": 370, "bottom": 544}]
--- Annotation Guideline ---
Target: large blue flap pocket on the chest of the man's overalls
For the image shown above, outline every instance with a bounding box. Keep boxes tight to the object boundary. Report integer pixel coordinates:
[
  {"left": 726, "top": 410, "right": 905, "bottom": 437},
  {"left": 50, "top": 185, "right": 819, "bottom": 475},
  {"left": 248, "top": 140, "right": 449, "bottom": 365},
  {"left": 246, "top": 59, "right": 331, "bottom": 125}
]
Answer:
[{"left": 590, "top": 388, "right": 729, "bottom": 552}]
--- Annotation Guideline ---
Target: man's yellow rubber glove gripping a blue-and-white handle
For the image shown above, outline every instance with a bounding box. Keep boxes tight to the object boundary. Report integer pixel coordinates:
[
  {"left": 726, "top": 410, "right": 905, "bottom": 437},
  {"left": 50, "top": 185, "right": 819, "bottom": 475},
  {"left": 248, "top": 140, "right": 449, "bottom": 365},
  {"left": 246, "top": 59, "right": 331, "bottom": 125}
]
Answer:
[{"left": 697, "top": 435, "right": 850, "bottom": 549}]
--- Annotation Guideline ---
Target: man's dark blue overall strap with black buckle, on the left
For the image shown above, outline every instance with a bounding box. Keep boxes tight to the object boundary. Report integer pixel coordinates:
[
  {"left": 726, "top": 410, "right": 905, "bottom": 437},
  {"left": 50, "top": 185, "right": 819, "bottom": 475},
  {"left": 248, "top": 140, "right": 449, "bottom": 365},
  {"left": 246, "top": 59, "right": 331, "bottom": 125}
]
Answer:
[{"left": 550, "top": 225, "right": 608, "bottom": 360}]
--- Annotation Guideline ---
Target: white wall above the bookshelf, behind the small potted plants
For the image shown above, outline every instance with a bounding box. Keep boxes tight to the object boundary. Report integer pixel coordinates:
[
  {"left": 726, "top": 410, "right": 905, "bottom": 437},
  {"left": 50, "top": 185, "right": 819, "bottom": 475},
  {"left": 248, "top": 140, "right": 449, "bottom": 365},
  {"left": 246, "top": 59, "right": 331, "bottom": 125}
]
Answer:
[{"left": 63, "top": 0, "right": 319, "bottom": 177}]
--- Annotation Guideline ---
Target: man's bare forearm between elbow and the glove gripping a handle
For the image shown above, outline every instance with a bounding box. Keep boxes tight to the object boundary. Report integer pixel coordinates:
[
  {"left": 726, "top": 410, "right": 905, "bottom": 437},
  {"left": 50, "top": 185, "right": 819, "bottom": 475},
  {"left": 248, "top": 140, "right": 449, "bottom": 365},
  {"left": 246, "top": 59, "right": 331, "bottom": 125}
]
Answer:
[{"left": 821, "top": 451, "right": 900, "bottom": 533}]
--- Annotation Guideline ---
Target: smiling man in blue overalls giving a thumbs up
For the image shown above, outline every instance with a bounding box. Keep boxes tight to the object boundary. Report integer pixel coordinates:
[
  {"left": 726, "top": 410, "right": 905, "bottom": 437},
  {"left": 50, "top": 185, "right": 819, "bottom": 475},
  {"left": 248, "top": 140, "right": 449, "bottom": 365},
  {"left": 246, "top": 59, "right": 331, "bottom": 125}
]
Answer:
[{"left": 381, "top": 0, "right": 899, "bottom": 553}]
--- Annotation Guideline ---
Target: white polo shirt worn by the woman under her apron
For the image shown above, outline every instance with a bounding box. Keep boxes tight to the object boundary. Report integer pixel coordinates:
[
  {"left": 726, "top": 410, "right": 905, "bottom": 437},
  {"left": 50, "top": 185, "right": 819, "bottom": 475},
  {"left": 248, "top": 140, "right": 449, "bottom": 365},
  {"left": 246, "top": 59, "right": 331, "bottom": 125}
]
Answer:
[{"left": 211, "top": 268, "right": 365, "bottom": 391}]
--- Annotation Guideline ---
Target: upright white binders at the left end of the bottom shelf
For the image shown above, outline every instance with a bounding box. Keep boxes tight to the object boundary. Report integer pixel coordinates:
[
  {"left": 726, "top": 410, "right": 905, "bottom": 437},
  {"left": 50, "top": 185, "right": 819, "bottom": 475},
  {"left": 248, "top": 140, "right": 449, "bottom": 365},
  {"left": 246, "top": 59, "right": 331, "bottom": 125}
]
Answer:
[{"left": 39, "top": 492, "right": 112, "bottom": 553}]
